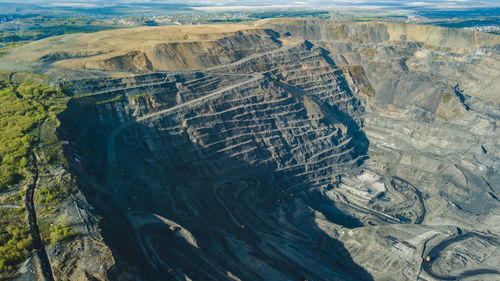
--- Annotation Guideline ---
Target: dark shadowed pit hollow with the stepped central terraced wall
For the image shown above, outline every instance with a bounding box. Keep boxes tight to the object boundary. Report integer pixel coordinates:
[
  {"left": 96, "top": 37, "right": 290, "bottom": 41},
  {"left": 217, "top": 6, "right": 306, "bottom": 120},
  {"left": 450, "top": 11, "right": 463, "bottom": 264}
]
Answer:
[{"left": 57, "top": 54, "right": 369, "bottom": 280}]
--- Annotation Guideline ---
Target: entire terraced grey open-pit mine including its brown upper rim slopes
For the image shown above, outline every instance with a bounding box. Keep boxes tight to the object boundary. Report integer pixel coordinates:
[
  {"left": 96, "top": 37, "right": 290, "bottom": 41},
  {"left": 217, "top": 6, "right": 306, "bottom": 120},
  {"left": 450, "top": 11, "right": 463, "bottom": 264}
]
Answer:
[{"left": 4, "top": 20, "right": 500, "bottom": 280}]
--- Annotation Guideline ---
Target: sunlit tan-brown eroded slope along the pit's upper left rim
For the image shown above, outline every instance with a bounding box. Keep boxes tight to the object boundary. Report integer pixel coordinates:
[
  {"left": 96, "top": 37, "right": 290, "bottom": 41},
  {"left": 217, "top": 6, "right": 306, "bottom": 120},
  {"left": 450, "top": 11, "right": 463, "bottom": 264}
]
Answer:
[{"left": 67, "top": 30, "right": 280, "bottom": 71}]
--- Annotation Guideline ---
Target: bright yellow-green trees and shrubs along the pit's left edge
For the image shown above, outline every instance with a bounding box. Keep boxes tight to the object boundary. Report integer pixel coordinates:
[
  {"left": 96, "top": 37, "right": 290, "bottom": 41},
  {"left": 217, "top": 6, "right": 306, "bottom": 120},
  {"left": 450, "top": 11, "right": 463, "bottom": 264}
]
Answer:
[{"left": 0, "top": 72, "right": 74, "bottom": 279}]
